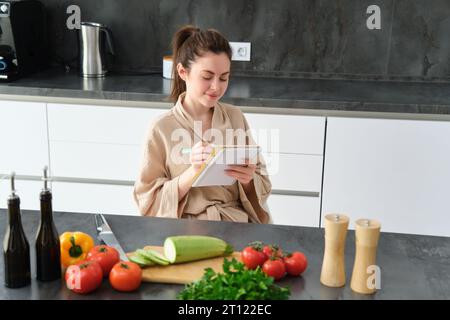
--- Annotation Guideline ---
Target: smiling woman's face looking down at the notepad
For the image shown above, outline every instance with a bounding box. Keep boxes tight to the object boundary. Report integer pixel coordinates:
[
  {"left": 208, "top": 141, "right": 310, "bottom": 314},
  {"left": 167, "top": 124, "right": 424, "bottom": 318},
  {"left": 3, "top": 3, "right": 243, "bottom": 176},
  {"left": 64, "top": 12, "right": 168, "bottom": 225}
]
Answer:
[{"left": 177, "top": 52, "right": 231, "bottom": 108}]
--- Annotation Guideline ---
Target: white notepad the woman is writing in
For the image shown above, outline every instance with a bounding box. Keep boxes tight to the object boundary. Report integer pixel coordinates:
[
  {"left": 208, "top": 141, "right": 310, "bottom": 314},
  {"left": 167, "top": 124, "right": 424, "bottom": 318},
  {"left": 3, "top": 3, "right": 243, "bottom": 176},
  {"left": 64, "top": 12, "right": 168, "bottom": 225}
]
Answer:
[{"left": 192, "top": 145, "right": 260, "bottom": 187}]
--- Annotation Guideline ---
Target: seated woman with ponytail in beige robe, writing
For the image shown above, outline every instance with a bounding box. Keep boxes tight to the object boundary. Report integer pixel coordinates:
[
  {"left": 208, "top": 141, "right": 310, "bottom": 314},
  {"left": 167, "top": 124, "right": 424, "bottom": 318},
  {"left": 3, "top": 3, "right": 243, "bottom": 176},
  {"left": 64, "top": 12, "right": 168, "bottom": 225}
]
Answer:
[{"left": 134, "top": 26, "right": 271, "bottom": 223}]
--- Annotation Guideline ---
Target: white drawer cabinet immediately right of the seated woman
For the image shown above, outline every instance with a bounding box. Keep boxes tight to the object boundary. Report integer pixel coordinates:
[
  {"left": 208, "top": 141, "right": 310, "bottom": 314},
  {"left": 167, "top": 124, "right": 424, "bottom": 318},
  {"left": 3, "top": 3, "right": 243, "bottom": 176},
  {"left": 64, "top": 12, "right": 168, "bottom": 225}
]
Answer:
[{"left": 245, "top": 113, "right": 325, "bottom": 227}]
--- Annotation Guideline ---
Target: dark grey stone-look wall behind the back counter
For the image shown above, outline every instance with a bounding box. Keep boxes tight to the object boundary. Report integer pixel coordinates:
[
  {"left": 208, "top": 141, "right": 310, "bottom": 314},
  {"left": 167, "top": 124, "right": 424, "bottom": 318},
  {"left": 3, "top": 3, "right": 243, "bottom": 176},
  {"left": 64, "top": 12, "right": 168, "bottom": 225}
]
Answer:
[{"left": 42, "top": 0, "right": 450, "bottom": 81}]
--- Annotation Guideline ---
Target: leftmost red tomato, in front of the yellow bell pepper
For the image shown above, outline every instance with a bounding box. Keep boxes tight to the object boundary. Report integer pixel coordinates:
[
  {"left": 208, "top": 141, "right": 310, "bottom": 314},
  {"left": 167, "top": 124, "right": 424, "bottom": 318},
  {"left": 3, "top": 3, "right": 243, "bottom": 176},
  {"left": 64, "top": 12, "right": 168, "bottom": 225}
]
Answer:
[{"left": 65, "top": 261, "right": 103, "bottom": 293}]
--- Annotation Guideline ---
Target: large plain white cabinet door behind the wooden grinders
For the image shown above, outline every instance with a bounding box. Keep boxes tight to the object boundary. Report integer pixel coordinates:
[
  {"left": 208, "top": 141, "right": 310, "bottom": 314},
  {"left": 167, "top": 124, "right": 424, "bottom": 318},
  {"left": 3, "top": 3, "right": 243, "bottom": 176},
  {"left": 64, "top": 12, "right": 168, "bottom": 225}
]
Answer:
[{"left": 322, "top": 118, "right": 450, "bottom": 236}]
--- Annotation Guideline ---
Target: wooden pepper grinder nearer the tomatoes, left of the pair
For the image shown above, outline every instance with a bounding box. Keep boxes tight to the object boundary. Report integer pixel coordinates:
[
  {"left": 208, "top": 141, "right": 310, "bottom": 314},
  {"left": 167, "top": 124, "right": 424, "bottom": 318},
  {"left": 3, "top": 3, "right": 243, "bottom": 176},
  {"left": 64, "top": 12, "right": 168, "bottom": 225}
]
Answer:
[{"left": 320, "top": 214, "right": 349, "bottom": 287}]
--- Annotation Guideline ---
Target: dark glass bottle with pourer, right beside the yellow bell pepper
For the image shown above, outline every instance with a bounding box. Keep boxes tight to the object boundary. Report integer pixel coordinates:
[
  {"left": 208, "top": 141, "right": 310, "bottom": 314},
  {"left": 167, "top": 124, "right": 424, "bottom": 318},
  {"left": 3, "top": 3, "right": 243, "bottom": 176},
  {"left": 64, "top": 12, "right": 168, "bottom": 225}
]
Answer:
[{"left": 36, "top": 167, "right": 61, "bottom": 281}]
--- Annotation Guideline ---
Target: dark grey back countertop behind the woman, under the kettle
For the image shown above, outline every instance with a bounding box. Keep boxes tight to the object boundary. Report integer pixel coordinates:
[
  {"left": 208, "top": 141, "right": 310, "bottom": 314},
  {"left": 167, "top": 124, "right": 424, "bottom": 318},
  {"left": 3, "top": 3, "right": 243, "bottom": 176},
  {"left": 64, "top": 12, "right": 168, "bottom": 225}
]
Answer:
[{"left": 0, "top": 68, "right": 450, "bottom": 115}]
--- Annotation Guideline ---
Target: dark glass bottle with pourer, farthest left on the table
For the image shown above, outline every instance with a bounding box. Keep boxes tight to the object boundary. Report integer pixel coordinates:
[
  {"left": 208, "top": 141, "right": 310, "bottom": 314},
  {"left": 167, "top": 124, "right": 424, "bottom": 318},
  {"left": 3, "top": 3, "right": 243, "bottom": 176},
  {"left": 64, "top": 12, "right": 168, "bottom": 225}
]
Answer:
[{"left": 3, "top": 173, "right": 31, "bottom": 288}]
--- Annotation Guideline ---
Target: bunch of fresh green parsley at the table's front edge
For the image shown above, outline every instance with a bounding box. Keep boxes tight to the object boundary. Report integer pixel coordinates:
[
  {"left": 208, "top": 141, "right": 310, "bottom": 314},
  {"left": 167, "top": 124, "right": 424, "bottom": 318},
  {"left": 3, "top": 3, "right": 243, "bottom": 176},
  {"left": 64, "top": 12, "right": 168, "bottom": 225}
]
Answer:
[{"left": 177, "top": 258, "right": 291, "bottom": 300}]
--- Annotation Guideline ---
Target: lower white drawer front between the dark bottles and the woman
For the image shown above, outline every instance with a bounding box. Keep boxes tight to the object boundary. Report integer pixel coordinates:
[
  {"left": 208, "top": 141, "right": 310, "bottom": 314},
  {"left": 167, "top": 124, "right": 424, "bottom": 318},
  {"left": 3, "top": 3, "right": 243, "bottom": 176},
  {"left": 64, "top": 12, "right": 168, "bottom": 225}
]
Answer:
[{"left": 52, "top": 181, "right": 139, "bottom": 216}]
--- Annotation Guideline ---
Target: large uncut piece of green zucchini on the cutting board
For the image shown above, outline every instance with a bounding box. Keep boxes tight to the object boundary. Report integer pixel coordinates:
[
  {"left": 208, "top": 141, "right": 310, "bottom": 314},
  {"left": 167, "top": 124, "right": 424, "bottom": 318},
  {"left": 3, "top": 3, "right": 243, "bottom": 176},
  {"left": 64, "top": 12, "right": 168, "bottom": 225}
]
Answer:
[{"left": 164, "top": 236, "right": 233, "bottom": 263}]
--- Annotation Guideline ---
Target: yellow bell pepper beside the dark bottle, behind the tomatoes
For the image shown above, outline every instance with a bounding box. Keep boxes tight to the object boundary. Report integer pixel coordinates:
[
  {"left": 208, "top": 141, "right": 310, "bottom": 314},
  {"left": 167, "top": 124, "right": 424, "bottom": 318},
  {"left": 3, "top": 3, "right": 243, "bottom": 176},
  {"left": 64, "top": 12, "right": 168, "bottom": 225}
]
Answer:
[{"left": 59, "top": 232, "right": 94, "bottom": 268}]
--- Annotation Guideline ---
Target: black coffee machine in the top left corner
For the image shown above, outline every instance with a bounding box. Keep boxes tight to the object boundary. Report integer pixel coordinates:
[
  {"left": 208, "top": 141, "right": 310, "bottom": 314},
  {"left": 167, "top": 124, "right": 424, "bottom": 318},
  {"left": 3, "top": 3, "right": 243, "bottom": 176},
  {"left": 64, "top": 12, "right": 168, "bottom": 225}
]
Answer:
[{"left": 0, "top": 0, "right": 49, "bottom": 81}]
